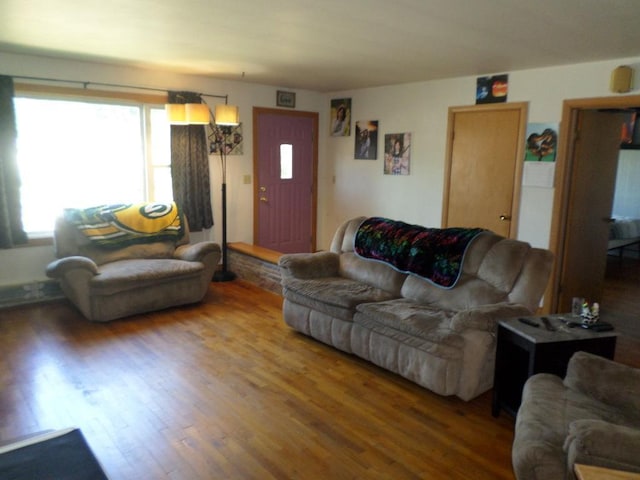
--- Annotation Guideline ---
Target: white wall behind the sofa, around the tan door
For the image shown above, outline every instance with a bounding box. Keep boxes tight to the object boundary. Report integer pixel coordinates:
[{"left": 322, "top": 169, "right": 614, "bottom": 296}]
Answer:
[{"left": 320, "top": 57, "right": 640, "bottom": 247}]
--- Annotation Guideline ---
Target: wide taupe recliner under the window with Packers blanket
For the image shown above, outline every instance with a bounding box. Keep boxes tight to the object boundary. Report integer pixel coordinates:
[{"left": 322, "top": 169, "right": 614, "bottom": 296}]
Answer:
[{"left": 46, "top": 204, "right": 221, "bottom": 322}]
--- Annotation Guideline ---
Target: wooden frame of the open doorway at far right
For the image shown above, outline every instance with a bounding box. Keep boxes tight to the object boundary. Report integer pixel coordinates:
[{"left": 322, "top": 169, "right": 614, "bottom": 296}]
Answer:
[{"left": 543, "top": 95, "right": 640, "bottom": 313}]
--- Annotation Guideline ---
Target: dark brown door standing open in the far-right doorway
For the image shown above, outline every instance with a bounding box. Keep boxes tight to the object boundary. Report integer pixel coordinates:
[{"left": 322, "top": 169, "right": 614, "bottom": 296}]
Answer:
[{"left": 558, "top": 110, "right": 624, "bottom": 312}]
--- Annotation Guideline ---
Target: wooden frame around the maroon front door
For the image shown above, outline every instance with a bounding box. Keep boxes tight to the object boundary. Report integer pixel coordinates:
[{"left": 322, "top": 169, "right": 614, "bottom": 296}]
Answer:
[{"left": 253, "top": 107, "right": 319, "bottom": 251}]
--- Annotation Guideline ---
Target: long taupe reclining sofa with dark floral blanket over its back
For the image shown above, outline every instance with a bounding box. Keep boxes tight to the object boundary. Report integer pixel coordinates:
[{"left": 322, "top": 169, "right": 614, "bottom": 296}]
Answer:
[{"left": 279, "top": 217, "right": 552, "bottom": 400}]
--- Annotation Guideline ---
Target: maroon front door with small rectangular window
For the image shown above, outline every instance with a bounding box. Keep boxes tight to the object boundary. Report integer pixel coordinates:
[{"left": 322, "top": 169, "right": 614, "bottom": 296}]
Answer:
[{"left": 254, "top": 109, "right": 318, "bottom": 253}]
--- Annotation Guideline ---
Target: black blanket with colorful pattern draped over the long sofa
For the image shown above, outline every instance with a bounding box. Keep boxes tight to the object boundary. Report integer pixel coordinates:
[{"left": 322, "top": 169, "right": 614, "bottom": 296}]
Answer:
[{"left": 354, "top": 217, "right": 485, "bottom": 288}]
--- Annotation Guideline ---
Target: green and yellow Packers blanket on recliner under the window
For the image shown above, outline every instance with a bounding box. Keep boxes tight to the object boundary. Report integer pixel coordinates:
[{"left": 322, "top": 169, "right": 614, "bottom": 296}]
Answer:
[{"left": 64, "top": 202, "right": 184, "bottom": 249}]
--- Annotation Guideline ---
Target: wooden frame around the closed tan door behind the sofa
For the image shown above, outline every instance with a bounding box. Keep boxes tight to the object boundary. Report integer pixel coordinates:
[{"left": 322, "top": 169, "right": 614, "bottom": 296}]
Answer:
[{"left": 441, "top": 102, "right": 529, "bottom": 238}]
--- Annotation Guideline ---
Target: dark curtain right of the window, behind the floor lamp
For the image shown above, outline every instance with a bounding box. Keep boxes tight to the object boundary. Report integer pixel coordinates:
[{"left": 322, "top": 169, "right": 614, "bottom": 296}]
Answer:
[{"left": 169, "top": 92, "right": 213, "bottom": 232}]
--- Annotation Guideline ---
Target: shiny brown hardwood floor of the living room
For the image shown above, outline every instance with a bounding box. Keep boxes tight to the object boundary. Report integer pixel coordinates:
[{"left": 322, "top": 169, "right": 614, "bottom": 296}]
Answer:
[{"left": 0, "top": 281, "right": 513, "bottom": 480}]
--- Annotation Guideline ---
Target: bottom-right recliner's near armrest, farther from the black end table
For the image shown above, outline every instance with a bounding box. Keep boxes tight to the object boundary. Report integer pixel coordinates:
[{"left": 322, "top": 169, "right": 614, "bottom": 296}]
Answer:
[{"left": 564, "top": 420, "right": 640, "bottom": 472}]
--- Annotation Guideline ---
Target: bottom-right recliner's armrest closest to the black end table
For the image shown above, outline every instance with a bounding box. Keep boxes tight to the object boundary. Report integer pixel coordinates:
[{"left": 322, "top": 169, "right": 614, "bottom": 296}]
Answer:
[{"left": 564, "top": 352, "right": 640, "bottom": 412}]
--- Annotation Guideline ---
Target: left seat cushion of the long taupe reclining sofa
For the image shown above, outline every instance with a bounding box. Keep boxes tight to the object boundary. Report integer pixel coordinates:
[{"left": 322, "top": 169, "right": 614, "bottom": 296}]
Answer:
[{"left": 282, "top": 277, "right": 395, "bottom": 321}]
